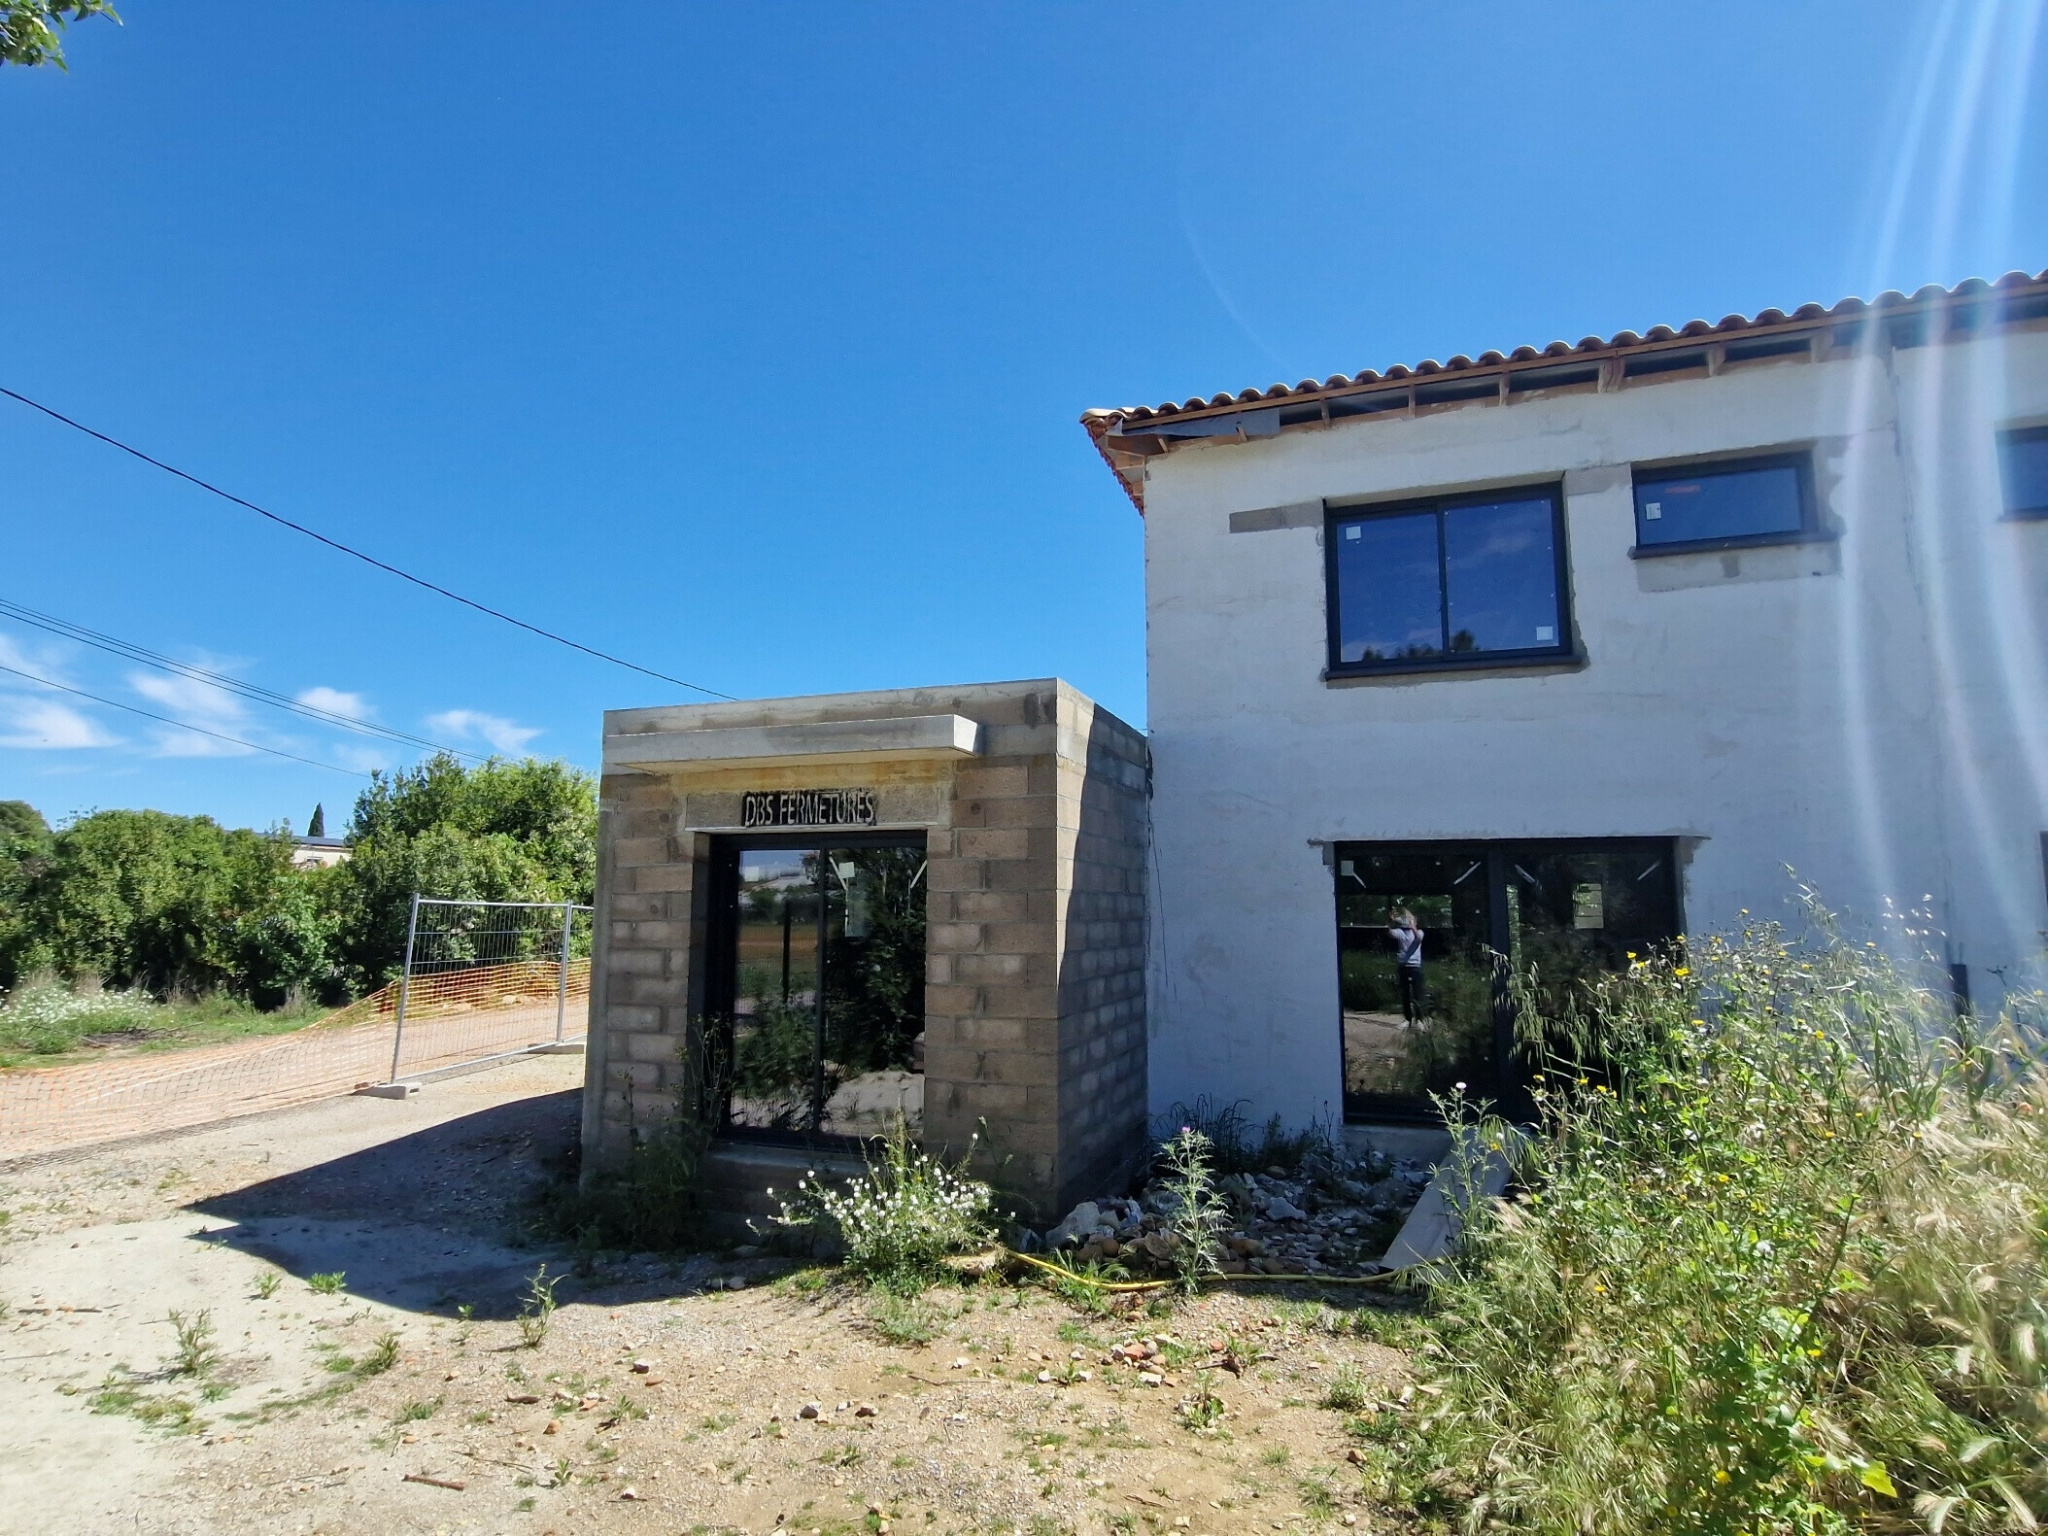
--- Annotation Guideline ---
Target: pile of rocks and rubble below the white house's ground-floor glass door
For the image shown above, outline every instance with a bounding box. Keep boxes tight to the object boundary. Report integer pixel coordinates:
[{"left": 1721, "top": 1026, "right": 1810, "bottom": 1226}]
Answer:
[{"left": 1044, "top": 1153, "right": 1430, "bottom": 1274}]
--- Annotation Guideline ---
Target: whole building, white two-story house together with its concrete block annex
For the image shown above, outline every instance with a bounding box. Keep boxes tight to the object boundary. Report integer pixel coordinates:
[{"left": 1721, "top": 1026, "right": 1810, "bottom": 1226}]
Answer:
[{"left": 584, "top": 272, "right": 2048, "bottom": 1212}]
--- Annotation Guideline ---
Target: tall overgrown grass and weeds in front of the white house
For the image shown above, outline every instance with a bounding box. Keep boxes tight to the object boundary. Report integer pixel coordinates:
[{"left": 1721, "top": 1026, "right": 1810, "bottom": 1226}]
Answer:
[{"left": 1358, "top": 913, "right": 2048, "bottom": 1536}]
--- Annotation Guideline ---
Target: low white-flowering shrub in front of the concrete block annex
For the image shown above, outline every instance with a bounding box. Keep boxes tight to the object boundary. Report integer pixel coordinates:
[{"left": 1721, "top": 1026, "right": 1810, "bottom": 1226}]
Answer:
[{"left": 770, "top": 1116, "right": 995, "bottom": 1296}]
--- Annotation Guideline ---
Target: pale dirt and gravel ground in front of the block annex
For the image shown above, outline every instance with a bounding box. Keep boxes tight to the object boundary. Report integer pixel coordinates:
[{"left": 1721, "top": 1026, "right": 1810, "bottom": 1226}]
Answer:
[{"left": 0, "top": 1057, "right": 1399, "bottom": 1536}]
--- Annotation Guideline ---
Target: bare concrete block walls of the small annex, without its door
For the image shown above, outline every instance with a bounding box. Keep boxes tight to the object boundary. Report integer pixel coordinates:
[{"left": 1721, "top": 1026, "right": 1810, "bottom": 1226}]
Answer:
[{"left": 584, "top": 680, "right": 1147, "bottom": 1214}]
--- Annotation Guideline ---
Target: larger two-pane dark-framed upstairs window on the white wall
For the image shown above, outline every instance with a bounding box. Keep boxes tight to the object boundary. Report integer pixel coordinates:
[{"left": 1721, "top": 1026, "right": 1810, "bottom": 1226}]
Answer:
[{"left": 1323, "top": 483, "right": 1571, "bottom": 676}]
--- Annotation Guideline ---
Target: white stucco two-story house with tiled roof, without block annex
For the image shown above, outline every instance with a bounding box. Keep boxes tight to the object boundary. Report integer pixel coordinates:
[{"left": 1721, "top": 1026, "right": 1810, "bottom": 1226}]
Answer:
[{"left": 1083, "top": 272, "right": 2048, "bottom": 1120}]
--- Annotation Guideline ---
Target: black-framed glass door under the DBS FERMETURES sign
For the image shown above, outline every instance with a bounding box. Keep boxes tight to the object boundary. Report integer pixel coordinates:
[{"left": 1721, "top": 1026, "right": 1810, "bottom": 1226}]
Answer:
[{"left": 707, "top": 834, "right": 926, "bottom": 1139}]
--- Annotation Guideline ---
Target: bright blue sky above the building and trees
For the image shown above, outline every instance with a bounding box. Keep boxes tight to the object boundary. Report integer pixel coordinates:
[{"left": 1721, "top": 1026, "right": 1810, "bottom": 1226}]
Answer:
[{"left": 0, "top": 0, "right": 2048, "bottom": 843}]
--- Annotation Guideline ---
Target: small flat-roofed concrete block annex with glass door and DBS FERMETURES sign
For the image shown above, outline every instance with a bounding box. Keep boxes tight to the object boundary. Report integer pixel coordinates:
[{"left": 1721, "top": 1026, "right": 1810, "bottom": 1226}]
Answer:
[{"left": 584, "top": 680, "right": 1147, "bottom": 1214}]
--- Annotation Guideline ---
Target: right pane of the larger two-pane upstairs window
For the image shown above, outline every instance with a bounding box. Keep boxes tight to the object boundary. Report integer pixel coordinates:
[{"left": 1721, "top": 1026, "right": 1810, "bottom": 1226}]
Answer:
[{"left": 1444, "top": 498, "right": 1563, "bottom": 655}]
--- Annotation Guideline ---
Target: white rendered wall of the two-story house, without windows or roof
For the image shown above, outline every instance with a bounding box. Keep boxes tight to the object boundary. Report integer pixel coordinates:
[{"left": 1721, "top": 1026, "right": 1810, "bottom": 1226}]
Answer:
[{"left": 1145, "top": 330, "right": 2048, "bottom": 1120}]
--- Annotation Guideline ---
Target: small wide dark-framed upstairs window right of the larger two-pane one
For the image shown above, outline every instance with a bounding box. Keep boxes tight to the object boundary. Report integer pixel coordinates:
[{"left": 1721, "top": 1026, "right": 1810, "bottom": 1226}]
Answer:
[{"left": 1630, "top": 453, "right": 1823, "bottom": 555}]
